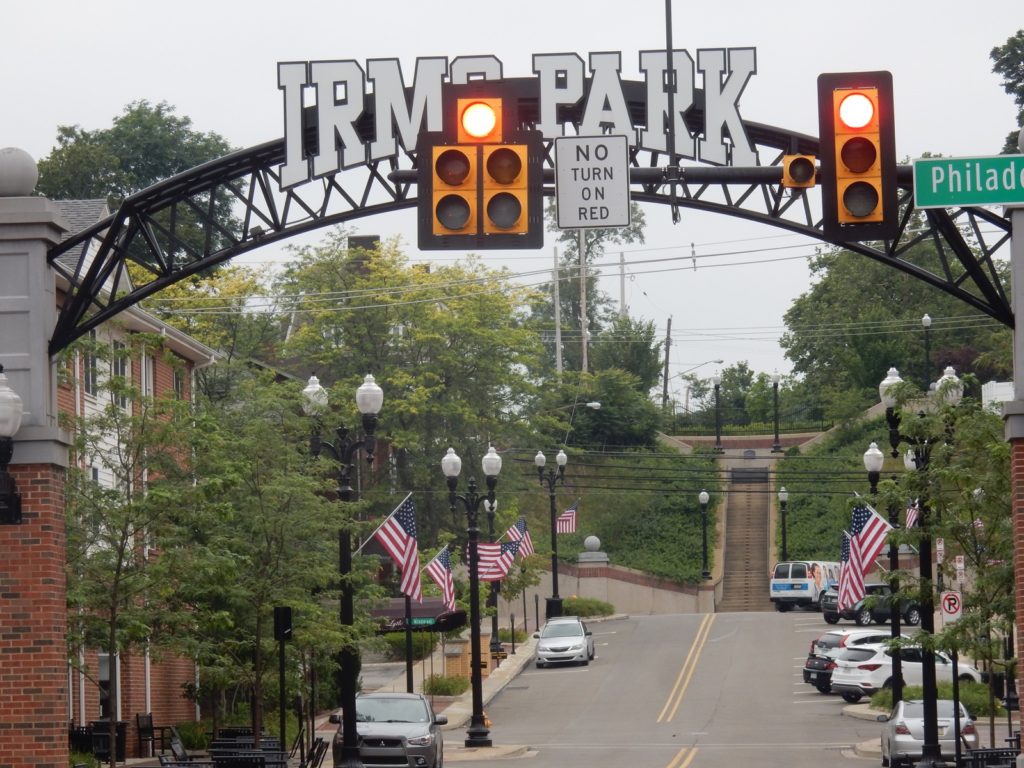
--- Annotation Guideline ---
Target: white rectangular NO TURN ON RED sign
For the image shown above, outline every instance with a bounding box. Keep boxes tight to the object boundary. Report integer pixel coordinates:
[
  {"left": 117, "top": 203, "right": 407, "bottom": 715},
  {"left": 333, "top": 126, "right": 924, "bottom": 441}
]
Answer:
[{"left": 555, "top": 135, "right": 630, "bottom": 229}]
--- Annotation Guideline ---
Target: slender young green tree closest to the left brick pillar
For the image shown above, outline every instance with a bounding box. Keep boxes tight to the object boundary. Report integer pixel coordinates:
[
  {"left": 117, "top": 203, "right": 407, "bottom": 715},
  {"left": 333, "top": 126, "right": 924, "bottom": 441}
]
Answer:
[{"left": 63, "top": 334, "right": 193, "bottom": 766}]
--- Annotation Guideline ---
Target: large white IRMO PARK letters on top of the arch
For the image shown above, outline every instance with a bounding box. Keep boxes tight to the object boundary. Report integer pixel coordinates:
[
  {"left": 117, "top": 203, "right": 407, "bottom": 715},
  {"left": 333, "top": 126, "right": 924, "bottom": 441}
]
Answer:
[{"left": 278, "top": 48, "right": 758, "bottom": 189}]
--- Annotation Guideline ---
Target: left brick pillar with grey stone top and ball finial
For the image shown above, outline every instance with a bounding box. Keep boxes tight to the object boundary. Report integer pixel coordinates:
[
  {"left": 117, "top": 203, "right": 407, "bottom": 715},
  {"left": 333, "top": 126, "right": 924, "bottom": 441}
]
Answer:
[{"left": 0, "top": 148, "right": 69, "bottom": 768}]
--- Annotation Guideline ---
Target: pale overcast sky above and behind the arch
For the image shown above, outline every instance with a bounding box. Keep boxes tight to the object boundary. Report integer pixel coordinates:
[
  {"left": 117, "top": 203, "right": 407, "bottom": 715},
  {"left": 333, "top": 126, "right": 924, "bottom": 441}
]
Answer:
[{"left": 0, "top": 0, "right": 1024, "bottom": 397}]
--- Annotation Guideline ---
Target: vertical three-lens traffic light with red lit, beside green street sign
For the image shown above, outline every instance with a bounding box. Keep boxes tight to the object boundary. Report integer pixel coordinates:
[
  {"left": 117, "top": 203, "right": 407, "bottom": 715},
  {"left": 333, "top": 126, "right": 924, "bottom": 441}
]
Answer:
[{"left": 818, "top": 72, "right": 899, "bottom": 242}]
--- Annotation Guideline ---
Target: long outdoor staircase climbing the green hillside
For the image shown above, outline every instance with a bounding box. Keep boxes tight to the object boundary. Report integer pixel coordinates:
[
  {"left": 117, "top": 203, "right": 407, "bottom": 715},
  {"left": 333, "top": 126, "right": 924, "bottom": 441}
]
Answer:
[{"left": 716, "top": 467, "right": 772, "bottom": 612}]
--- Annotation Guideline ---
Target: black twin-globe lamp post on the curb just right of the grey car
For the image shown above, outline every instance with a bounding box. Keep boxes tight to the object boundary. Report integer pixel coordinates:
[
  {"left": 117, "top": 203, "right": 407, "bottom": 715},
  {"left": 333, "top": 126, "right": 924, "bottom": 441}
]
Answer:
[{"left": 441, "top": 446, "right": 502, "bottom": 746}]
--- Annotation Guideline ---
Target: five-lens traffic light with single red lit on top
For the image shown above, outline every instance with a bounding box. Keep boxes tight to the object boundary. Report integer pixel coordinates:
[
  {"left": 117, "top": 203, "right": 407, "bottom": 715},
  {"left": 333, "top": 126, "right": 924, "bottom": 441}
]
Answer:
[{"left": 417, "top": 82, "right": 544, "bottom": 250}]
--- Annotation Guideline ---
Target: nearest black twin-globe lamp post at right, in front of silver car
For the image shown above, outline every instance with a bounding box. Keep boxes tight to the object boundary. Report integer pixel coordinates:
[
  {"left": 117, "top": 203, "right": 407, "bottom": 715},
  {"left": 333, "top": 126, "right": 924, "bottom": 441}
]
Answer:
[{"left": 879, "top": 367, "right": 964, "bottom": 766}]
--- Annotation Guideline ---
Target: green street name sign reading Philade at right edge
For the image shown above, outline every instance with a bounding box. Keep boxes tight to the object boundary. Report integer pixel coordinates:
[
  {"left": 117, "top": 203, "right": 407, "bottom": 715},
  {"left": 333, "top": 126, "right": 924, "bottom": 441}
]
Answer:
[{"left": 913, "top": 155, "right": 1024, "bottom": 208}]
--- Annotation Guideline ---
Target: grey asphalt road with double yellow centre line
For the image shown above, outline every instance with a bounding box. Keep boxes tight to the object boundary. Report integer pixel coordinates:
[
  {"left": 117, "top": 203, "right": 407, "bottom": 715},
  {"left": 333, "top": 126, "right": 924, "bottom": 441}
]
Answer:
[{"left": 452, "top": 612, "right": 880, "bottom": 768}]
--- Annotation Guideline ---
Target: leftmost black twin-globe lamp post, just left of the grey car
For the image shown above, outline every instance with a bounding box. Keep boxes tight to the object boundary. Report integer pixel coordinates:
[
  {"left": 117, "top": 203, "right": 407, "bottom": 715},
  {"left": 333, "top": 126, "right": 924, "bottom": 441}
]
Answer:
[{"left": 302, "top": 374, "right": 384, "bottom": 768}]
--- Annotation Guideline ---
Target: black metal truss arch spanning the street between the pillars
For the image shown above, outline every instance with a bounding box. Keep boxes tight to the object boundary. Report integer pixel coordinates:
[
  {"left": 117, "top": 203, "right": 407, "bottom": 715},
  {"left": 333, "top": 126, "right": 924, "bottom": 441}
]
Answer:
[{"left": 48, "top": 78, "right": 1014, "bottom": 354}]
